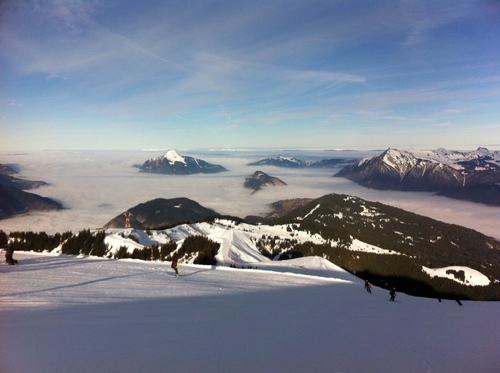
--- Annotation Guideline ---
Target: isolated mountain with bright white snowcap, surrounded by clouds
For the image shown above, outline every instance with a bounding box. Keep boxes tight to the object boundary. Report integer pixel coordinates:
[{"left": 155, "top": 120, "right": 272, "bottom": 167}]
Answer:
[{"left": 136, "top": 150, "right": 227, "bottom": 175}]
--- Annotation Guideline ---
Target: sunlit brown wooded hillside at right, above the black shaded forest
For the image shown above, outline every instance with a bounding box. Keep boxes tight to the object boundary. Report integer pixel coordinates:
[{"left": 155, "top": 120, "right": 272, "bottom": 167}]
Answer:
[{"left": 269, "top": 194, "right": 500, "bottom": 281}]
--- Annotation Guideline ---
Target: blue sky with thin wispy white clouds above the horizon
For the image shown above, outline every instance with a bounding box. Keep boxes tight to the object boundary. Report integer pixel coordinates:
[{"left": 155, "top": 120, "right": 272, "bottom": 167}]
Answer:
[{"left": 0, "top": 0, "right": 500, "bottom": 150}]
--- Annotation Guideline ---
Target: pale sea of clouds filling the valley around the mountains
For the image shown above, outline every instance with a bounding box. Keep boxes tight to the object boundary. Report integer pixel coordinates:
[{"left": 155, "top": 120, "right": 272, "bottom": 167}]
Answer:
[{"left": 0, "top": 149, "right": 500, "bottom": 239}]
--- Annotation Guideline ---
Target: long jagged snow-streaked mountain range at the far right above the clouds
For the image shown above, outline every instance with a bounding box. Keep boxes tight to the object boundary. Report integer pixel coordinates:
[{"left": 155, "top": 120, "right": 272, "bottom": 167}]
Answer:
[{"left": 334, "top": 148, "right": 500, "bottom": 206}]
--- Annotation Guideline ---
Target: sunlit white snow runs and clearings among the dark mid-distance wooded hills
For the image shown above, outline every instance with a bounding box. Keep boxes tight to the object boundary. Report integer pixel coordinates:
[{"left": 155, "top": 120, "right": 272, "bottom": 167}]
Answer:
[{"left": 95, "top": 217, "right": 490, "bottom": 286}]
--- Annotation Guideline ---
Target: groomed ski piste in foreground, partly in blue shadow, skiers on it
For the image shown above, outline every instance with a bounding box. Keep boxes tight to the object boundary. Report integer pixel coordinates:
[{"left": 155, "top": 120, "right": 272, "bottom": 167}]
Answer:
[{"left": 0, "top": 252, "right": 500, "bottom": 373}]
